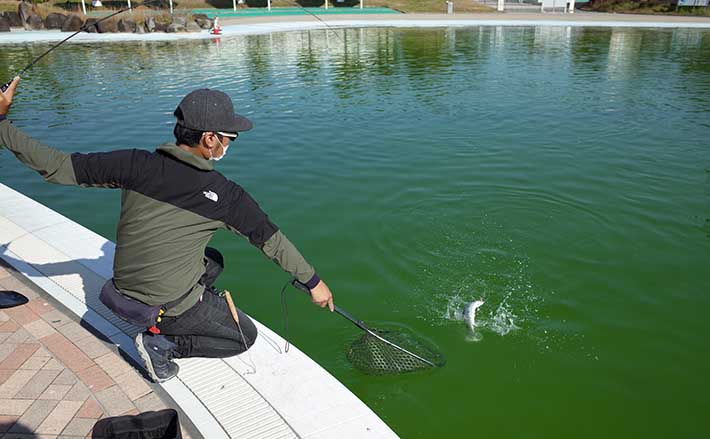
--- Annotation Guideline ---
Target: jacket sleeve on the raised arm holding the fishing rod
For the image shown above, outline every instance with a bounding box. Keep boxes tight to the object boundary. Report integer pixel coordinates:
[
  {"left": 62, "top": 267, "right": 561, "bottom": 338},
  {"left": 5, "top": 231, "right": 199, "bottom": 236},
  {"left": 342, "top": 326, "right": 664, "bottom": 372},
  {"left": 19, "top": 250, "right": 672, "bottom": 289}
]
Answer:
[{"left": 0, "top": 120, "right": 146, "bottom": 188}]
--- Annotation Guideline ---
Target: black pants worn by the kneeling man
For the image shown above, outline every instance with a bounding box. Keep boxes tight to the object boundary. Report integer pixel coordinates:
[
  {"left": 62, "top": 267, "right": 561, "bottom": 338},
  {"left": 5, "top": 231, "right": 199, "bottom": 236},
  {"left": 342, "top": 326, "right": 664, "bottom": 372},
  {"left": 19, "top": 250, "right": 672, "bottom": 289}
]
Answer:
[{"left": 157, "top": 247, "right": 257, "bottom": 358}]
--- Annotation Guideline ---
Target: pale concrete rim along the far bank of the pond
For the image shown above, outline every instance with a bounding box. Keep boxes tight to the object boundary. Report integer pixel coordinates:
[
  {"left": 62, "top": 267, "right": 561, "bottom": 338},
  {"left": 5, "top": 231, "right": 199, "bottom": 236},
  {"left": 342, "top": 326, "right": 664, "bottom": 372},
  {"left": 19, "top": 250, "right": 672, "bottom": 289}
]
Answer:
[{"left": 0, "top": 12, "right": 710, "bottom": 45}]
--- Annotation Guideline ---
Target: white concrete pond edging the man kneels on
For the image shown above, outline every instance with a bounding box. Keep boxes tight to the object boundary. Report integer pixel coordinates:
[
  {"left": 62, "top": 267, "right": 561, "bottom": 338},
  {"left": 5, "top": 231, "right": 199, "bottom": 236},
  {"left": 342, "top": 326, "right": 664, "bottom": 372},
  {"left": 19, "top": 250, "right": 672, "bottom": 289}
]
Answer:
[{"left": 0, "top": 184, "right": 397, "bottom": 439}]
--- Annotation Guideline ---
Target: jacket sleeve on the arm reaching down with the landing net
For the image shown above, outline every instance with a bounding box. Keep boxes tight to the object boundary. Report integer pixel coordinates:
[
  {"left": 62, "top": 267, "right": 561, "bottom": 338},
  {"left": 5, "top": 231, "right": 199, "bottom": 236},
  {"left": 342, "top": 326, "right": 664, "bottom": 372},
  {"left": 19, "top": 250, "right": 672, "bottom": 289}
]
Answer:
[{"left": 225, "top": 184, "right": 319, "bottom": 288}]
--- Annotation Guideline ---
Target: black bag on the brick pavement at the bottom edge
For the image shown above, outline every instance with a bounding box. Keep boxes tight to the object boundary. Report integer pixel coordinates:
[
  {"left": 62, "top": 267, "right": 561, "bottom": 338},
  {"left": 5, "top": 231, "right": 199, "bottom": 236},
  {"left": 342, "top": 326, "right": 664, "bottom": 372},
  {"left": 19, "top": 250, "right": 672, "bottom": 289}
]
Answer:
[{"left": 91, "top": 409, "right": 182, "bottom": 439}]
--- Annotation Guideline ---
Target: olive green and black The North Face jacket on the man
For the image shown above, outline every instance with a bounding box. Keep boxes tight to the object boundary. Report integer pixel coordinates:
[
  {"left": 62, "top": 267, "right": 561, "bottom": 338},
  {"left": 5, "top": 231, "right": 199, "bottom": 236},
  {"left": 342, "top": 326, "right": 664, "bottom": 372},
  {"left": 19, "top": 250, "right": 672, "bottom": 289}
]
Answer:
[{"left": 0, "top": 120, "right": 319, "bottom": 315}]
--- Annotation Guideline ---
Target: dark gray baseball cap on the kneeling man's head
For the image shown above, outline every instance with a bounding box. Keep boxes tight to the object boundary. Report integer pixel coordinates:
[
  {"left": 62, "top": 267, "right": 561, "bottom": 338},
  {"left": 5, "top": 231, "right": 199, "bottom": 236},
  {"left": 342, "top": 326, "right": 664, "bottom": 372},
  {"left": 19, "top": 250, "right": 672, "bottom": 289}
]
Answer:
[{"left": 173, "top": 88, "right": 253, "bottom": 135}]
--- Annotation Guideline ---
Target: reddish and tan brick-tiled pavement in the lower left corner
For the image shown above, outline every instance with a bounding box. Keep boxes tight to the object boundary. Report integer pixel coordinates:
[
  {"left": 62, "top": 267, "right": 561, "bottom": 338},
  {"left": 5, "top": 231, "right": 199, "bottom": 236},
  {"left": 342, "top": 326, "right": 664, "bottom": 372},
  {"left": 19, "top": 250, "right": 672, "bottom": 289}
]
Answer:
[{"left": 0, "top": 261, "right": 194, "bottom": 439}]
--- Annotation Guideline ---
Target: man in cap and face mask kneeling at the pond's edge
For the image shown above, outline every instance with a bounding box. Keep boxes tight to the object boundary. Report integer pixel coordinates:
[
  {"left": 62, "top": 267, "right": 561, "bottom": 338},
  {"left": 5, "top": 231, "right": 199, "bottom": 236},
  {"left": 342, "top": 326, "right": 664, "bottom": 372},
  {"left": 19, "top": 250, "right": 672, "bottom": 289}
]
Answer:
[{"left": 0, "top": 77, "right": 333, "bottom": 382}]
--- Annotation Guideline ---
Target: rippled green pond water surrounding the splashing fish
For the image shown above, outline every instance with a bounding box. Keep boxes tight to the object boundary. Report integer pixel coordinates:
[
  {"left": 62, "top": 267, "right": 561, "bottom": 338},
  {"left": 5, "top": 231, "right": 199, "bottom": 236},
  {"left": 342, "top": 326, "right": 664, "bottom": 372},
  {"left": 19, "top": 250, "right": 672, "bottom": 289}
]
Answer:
[{"left": 0, "top": 27, "right": 710, "bottom": 438}]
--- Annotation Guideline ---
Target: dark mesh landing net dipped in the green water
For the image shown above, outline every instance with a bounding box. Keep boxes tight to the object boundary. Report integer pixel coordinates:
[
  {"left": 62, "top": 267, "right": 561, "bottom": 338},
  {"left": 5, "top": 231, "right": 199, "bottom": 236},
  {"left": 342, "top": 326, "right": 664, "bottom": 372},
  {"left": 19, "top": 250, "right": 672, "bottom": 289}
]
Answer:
[{"left": 347, "top": 329, "right": 446, "bottom": 375}]
